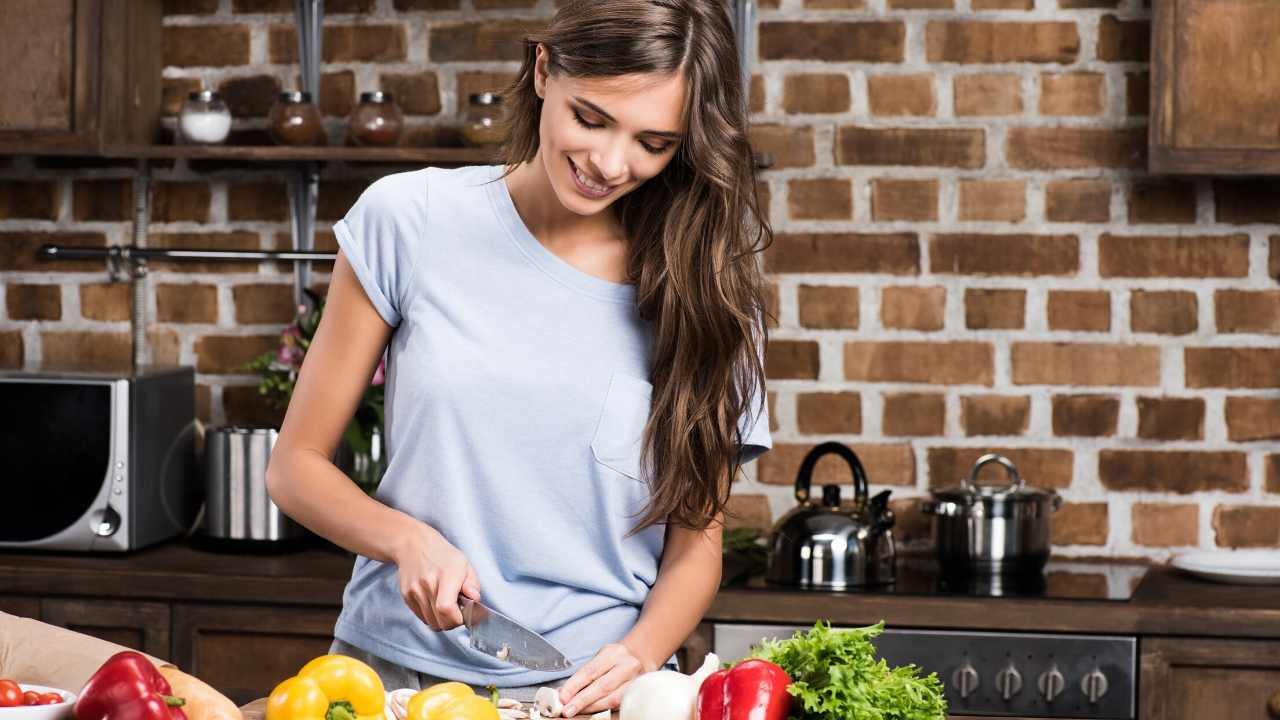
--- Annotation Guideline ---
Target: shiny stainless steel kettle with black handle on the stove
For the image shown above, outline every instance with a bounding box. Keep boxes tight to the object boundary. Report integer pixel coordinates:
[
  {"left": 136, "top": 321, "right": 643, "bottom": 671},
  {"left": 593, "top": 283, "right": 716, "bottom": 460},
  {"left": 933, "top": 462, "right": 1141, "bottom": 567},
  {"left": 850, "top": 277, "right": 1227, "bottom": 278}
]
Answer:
[{"left": 765, "top": 442, "right": 896, "bottom": 591}]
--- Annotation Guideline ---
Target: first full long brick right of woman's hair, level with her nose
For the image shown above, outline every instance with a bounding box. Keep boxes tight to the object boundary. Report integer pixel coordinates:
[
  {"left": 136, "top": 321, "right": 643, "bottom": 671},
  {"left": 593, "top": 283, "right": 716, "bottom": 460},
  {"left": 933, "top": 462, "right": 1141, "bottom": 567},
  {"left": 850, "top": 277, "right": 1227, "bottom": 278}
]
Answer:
[{"left": 836, "top": 126, "right": 987, "bottom": 169}]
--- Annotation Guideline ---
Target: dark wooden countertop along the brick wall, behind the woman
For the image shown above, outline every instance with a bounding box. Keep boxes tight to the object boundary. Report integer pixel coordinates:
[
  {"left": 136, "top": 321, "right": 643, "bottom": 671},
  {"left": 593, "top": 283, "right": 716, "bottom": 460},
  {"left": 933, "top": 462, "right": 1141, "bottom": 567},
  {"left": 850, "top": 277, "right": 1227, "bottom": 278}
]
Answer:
[{"left": 0, "top": 542, "right": 1280, "bottom": 638}]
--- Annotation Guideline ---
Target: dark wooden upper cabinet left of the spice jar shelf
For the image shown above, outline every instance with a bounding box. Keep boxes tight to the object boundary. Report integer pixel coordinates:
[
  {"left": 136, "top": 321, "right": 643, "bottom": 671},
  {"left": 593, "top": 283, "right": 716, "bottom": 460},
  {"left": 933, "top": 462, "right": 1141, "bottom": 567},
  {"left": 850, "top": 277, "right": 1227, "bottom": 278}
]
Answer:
[{"left": 0, "top": 0, "right": 163, "bottom": 155}]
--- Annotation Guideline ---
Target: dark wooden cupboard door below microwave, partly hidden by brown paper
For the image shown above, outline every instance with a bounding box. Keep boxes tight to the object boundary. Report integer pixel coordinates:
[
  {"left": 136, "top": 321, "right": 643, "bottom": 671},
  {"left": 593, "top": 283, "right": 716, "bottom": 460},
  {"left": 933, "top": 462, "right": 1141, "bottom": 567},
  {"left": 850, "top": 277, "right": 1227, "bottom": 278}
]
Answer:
[{"left": 41, "top": 600, "right": 169, "bottom": 659}]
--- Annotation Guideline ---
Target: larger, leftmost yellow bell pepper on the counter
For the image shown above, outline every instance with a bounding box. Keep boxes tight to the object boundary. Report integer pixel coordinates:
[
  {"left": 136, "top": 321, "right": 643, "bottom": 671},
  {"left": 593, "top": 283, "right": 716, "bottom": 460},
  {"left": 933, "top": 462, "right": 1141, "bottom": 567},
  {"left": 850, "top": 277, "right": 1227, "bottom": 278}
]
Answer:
[{"left": 266, "top": 655, "right": 387, "bottom": 720}]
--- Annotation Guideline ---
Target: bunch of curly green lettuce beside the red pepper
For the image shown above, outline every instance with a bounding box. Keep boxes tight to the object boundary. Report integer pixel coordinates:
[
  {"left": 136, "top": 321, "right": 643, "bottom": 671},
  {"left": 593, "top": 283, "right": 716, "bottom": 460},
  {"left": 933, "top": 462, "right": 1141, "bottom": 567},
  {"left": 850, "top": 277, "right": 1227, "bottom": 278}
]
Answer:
[{"left": 750, "top": 620, "right": 947, "bottom": 720}]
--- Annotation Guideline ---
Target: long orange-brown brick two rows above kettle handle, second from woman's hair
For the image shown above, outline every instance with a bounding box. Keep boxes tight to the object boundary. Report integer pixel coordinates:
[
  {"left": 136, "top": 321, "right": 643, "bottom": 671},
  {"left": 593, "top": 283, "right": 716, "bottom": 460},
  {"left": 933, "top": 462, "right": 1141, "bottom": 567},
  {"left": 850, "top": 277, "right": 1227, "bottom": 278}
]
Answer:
[{"left": 845, "top": 342, "right": 995, "bottom": 386}]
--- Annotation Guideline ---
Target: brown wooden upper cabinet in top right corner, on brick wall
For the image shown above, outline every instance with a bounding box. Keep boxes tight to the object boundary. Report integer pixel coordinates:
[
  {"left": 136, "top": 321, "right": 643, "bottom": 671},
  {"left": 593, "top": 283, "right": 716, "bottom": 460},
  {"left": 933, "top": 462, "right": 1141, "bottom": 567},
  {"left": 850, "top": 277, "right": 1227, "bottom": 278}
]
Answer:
[{"left": 1148, "top": 0, "right": 1280, "bottom": 174}]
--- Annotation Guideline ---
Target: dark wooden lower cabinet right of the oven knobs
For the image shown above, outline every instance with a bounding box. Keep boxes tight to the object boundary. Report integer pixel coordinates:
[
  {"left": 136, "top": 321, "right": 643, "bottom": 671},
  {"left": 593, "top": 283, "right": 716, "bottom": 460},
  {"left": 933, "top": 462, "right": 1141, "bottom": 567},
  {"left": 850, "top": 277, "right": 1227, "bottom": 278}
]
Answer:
[{"left": 1138, "top": 638, "right": 1280, "bottom": 720}]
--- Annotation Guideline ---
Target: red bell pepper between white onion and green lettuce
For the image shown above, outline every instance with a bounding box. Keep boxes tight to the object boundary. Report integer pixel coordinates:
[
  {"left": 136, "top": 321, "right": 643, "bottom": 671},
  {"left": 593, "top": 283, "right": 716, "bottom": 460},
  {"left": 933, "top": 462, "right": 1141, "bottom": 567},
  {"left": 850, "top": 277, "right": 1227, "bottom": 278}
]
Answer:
[{"left": 694, "top": 660, "right": 791, "bottom": 720}]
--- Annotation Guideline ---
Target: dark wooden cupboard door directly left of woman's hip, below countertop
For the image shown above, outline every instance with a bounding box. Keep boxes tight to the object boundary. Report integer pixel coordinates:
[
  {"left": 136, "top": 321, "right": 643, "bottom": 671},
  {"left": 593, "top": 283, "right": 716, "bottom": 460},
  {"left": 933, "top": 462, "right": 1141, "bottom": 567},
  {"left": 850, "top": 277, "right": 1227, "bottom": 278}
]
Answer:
[{"left": 173, "top": 605, "right": 339, "bottom": 705}]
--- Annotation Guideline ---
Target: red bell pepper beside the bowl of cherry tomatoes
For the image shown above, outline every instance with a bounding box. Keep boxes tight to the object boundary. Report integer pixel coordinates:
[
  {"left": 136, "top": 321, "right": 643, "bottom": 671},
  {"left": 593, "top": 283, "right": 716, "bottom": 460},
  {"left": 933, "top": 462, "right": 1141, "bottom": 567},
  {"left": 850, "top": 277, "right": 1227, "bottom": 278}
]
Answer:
[{"left": 74, "top": 651, "right": 187, "bottom": 720}]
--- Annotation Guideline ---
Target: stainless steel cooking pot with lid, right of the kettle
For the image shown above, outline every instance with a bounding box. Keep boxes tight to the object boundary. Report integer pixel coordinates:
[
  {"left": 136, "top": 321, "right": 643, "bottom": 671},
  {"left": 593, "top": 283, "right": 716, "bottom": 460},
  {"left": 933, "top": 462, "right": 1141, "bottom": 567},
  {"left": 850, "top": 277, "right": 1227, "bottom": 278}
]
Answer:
[{"left": 922, "top": 454, "right": 1062, "bottom": 575}]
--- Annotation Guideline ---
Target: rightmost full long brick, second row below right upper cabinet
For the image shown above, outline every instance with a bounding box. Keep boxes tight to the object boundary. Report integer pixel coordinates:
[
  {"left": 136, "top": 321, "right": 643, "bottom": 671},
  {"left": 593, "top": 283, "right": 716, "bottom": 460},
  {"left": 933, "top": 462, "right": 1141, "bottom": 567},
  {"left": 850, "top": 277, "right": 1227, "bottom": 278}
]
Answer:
[{"left": 1098, "top": 233, "right": 1249, "bottom": 278}]
